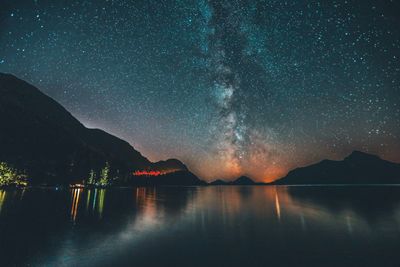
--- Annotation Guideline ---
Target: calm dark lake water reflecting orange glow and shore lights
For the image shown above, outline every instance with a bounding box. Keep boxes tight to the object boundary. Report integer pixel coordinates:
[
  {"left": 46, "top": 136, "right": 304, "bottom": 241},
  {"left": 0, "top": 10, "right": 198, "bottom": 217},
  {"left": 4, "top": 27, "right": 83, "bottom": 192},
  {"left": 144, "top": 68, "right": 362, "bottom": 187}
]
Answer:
[{"left": 0, "top": 186, "right": 400, "bottom": 267}]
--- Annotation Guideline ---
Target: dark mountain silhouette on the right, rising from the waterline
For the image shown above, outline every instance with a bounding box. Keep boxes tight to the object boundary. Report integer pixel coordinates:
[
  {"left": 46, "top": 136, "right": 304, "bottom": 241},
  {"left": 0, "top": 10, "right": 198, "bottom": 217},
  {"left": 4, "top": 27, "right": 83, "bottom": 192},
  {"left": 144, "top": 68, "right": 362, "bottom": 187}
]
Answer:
[{"left": 273, "top": 151, "right": 400, "bottom": 184}]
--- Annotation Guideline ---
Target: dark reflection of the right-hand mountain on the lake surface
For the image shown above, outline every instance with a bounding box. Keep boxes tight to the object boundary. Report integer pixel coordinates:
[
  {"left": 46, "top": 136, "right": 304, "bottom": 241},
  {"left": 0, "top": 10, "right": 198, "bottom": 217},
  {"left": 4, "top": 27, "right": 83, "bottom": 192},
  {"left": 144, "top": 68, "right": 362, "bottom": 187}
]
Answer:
[{"left": 288, "top": 186, "right": 400, "bottom": 226}]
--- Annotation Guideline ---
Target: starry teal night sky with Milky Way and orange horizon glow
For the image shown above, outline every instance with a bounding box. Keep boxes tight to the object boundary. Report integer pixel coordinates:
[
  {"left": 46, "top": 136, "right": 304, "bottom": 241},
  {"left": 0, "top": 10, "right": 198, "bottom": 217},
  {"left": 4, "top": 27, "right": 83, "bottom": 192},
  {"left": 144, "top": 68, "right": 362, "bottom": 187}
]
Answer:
[{"left": 0, "top": 0, "right": 400, "bottom": 181}]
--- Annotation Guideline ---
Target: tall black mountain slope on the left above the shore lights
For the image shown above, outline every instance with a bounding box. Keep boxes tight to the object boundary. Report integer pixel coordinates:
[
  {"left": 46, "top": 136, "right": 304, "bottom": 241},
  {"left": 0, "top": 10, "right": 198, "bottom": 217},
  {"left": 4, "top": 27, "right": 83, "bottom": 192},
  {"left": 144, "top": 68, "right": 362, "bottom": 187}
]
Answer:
[{"left": 0, "top": 73, "right": 200, "bottom": 184}]
